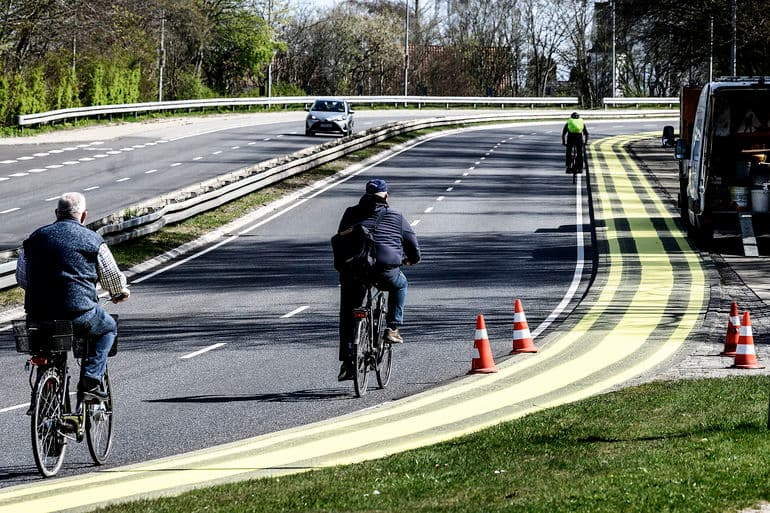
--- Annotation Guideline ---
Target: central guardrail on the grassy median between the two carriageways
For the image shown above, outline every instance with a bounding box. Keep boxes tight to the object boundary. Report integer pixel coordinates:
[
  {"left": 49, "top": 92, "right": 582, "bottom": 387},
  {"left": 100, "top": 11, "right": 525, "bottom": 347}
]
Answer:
[{"left": 0, "top": 106, "right": 673, "bottom": 290}]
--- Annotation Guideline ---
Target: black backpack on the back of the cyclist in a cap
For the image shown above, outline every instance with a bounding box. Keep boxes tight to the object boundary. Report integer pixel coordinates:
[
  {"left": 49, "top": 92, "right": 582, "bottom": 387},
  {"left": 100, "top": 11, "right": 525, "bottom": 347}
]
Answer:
[{"left": 332, "top": 208, "right": 388, "bottom": 282}]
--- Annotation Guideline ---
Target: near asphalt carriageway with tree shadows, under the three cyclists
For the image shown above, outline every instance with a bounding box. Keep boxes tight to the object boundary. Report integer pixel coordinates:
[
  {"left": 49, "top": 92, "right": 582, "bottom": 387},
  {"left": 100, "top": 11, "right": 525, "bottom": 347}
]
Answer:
[{"left": 0, "top": 117, "right": 663, "bottom": 486}]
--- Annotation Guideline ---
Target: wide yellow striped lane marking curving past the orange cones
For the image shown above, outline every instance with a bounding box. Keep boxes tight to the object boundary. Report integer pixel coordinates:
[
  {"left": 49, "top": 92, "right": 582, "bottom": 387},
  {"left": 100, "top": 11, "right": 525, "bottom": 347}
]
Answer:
[{"left": 0, "top": 133, "right": 706, "bottom": 512}]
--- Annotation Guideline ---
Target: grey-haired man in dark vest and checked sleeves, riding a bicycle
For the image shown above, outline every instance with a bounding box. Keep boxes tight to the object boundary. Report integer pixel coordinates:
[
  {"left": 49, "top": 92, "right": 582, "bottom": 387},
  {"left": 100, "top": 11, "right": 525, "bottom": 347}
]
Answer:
[{"left": 16, "top": 192, "right": 130, "bottom": 395}]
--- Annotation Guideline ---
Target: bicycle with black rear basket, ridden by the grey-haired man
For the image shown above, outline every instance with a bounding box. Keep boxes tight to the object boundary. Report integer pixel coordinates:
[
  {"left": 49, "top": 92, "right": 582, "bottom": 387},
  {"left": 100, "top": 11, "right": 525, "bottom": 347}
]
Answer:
[{"left": 13, "top": 315, "right": 118, "bottom": 477}]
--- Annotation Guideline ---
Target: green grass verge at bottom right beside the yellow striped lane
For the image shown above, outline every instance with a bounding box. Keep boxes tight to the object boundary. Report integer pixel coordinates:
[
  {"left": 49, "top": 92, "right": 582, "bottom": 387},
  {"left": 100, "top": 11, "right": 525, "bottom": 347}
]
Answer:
[{"left": 94, "top": 376, "right": 770, "bottom": 513}]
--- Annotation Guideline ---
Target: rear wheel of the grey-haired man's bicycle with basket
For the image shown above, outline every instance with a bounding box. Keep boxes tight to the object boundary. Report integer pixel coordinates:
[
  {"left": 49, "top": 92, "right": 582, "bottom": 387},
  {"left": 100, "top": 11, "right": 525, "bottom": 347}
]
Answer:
[{"left": 32, "top": 368, "right": 67, "bottom": 477}]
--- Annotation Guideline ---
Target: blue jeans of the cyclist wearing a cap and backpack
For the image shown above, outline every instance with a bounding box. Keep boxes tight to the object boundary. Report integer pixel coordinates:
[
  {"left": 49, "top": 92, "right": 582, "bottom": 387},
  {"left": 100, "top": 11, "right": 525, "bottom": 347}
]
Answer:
[{"left": 339, "top": 268, "right": 409, "bottom": 361}]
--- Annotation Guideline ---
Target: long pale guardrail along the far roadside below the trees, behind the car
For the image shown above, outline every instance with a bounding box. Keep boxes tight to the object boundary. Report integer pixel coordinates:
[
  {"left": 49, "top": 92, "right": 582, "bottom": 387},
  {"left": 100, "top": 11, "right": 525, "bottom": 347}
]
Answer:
[{"left": 16, "top": 96, "right": 578, "bottom": 127}]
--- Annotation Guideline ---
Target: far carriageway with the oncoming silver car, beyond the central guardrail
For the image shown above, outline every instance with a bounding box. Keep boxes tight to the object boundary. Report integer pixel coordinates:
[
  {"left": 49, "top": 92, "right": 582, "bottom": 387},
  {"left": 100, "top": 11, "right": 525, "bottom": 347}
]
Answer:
[{"left": 0, "top": 110, "right": 552, "bottom": 252}]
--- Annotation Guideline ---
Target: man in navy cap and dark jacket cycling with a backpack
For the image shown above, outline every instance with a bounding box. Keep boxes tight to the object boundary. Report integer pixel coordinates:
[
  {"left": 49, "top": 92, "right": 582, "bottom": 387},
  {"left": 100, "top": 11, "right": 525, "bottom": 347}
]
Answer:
[{"left": 338, "top": 180, "right": 420, "bottom": 381}]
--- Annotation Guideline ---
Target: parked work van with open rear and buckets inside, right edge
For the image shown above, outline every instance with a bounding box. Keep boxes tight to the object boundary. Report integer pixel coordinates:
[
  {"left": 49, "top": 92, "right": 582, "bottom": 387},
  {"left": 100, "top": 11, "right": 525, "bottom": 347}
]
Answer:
[{"left": 676, "top": 77, "right": 770, "bottom": 241}]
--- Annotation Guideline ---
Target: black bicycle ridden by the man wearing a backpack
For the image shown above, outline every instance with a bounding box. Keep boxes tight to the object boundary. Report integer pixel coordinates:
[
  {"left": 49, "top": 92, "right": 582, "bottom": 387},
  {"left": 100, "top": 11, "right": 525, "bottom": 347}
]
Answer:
[{"left": 353, "top": 285, "right": 393, "bottom": 397}]
